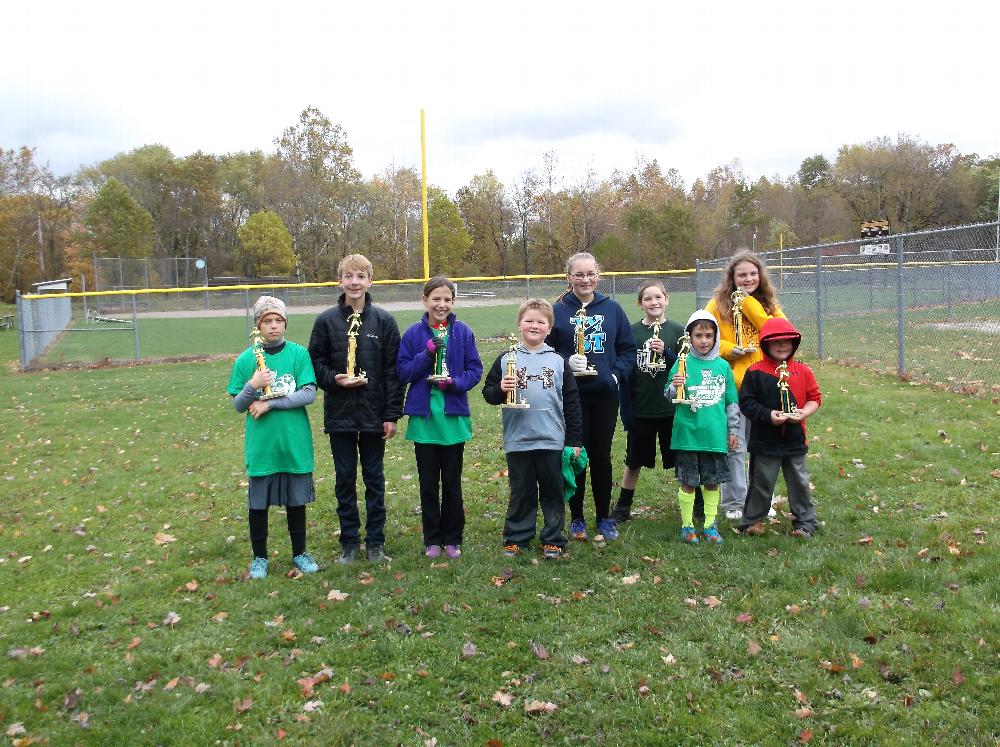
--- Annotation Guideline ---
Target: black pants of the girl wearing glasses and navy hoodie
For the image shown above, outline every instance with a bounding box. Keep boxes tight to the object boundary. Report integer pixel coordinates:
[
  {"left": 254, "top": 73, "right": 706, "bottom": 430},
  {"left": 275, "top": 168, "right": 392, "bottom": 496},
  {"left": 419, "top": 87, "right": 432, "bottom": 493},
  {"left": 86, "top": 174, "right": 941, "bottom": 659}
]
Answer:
[{"left": 569, "top": 392, "right": 618, "bottom": 521}]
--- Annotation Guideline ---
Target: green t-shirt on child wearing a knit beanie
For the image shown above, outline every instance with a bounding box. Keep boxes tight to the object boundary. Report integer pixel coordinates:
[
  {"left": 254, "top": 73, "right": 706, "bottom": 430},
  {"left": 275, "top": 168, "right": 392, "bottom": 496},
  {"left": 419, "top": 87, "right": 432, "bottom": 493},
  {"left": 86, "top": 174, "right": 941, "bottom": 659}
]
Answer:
[{"left": 226, "top": 341, "right": 316, "bottom": 477}]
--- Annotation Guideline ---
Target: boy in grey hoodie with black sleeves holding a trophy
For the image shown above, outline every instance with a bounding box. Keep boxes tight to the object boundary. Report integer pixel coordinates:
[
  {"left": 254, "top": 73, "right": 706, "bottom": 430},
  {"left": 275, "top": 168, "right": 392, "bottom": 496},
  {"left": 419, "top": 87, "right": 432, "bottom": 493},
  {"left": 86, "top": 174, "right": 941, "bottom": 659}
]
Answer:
[{"left": 483, "top": 299, "right": 583, "bottom": 559}]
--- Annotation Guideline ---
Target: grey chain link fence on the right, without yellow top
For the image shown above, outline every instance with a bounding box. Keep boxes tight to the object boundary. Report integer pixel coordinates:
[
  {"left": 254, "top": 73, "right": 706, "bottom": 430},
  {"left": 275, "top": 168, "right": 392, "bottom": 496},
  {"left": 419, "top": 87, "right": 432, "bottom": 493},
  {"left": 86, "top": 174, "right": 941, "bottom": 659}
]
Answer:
[{"left": 695, "top": 223, "right": 1000, "bottom": 396}]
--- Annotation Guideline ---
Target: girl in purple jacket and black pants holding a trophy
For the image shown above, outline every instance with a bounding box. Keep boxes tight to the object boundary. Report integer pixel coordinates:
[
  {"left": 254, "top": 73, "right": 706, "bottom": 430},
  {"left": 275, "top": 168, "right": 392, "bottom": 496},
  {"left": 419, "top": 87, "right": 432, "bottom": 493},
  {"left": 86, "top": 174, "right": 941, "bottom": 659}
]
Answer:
[{"left": 396, "top": 277, "right": 483, "bottom": 558}]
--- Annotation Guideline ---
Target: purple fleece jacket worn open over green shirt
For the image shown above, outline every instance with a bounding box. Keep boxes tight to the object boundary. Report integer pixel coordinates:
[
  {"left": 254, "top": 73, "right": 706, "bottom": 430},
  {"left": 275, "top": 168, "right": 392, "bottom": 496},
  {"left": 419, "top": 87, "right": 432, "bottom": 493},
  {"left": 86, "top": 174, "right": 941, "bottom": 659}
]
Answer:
[{"left": 396, "top": 313, "right": 483, "bottom": 417}]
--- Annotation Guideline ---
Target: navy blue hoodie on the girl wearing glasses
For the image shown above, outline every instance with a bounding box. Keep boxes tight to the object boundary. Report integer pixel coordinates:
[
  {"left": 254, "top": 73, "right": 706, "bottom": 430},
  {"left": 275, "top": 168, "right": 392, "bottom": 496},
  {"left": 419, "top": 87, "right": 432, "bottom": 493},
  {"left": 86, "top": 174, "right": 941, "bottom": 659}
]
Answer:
[{"left": 545, "top": 291, "right": 635, "bottom": 397}]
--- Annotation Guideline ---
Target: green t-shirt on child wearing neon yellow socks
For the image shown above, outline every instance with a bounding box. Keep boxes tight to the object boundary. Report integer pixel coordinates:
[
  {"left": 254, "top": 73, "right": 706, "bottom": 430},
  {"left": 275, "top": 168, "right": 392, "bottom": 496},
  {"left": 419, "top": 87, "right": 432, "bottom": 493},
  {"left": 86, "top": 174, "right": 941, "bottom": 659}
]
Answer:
[{"left": 667, "top": 355, "right": 739, "bottom": 454}]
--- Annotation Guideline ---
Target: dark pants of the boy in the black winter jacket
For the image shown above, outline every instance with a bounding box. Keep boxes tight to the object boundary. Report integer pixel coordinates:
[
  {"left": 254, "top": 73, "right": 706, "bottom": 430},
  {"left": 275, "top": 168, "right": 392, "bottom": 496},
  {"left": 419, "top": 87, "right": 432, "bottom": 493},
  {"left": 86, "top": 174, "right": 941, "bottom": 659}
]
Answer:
[{"left": 330, "top": 433, "right": 385, "bottom": 547}]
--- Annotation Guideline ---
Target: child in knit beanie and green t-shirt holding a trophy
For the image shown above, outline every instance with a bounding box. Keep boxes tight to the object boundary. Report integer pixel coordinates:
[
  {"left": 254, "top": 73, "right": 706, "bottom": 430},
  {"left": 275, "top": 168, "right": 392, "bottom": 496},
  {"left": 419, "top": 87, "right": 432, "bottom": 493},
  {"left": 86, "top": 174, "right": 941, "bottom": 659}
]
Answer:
[{"left": 226, "top": 296, "right": 319, "bottom": 579}]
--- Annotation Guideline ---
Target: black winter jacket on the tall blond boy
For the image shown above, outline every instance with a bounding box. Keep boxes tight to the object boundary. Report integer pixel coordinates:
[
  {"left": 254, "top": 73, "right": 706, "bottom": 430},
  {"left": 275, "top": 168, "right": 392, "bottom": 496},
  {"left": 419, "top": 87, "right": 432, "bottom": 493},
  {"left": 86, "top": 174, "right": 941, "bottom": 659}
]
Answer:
[{"left": 309, "top": 293, "right": 403, "bottom": 433}]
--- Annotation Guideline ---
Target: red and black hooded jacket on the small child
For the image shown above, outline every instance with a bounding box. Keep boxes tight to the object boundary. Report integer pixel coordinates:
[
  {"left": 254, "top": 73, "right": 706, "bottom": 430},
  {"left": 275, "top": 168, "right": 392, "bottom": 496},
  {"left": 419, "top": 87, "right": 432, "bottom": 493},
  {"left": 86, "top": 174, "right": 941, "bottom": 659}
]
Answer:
[{"left": 740, "top": 318, "right": 823, "bottom": 456}]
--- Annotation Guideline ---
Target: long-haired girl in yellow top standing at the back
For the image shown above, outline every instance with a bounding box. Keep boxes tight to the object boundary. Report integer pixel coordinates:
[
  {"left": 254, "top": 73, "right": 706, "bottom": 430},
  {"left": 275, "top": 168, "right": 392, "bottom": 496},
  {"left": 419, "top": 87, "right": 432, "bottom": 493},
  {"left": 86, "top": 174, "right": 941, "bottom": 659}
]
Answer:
[{"left": 705, "top": 250, "right": 785, "bottom": 521}]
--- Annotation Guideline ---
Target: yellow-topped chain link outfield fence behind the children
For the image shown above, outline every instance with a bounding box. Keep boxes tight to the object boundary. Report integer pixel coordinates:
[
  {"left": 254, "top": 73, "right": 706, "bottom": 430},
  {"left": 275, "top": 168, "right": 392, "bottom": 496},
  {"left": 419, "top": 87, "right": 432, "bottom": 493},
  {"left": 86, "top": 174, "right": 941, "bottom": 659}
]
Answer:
[{"left": 17, "top": 270, "right": 694, "bottom": 370}]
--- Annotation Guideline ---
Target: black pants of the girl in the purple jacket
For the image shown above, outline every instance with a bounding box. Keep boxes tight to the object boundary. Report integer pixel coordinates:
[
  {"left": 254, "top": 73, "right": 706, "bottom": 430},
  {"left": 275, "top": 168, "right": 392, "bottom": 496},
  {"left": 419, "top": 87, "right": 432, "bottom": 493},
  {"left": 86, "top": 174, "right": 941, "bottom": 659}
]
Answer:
[{"left": 413, "top": 443, "right": 465, "bottom": 546}]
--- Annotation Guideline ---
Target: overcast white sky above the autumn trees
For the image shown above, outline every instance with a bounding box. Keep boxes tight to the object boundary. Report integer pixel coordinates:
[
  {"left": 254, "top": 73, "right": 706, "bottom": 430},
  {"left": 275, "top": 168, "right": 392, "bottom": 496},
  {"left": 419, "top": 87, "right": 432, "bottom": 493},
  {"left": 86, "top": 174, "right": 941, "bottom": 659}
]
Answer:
[{"left": 0, "top": 0, "right": 1000, "bottom": 192}]
